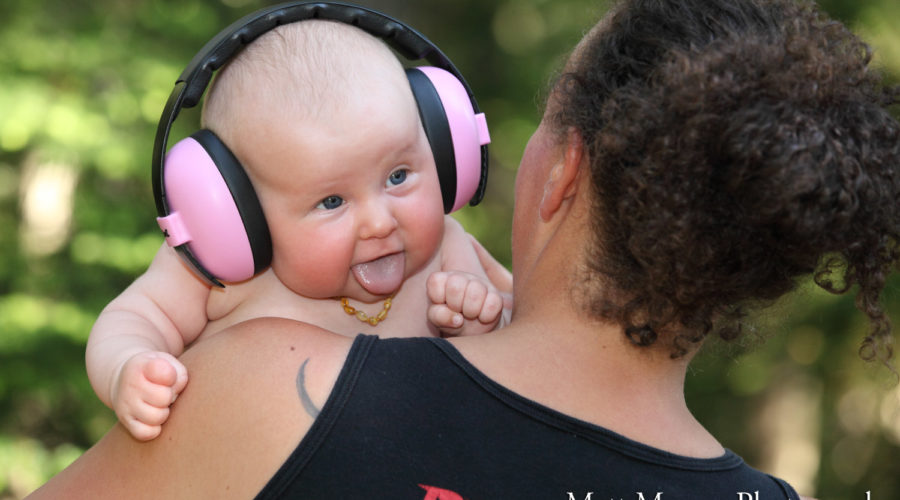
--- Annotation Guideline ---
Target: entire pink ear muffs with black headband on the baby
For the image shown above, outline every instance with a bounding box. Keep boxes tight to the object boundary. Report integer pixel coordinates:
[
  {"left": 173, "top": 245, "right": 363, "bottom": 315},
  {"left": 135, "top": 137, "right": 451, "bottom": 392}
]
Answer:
[{"left": 152, "top": 2, "right": 490, "bottom": 286}]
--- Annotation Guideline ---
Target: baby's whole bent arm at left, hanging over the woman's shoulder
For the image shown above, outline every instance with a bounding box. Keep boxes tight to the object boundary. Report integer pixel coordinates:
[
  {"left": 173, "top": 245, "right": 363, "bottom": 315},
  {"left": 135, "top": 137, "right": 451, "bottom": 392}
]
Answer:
[{"left": 86, "top": 245, "right": 209, "bottom": 440}]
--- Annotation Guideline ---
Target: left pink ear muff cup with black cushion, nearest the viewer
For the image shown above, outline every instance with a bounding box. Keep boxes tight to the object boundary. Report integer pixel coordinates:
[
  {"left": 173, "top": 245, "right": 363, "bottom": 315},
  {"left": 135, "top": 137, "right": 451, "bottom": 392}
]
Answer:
[{"left": 160, "top": 130, "right": 272, "bottom": 283}]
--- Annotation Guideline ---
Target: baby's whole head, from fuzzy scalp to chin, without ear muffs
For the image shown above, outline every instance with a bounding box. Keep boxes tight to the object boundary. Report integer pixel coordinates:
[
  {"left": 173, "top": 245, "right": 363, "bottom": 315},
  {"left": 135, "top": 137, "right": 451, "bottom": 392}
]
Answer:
[{"left": 203, "top": 20, "right": 443, "bottom": 301}]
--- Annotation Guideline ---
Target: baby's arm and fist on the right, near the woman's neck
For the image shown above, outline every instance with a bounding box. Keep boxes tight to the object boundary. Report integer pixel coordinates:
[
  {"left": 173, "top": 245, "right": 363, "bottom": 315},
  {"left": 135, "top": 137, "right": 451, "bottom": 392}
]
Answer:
[{"left": 427, "top": 216, "right": 512, "bottom": 335}]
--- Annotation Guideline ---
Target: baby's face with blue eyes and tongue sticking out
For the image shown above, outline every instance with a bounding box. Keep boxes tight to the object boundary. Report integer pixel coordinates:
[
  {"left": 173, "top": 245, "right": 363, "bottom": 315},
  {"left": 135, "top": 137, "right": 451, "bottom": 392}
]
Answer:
[{"left": 241, "top": 81, "right": 444, "bottom": 302}]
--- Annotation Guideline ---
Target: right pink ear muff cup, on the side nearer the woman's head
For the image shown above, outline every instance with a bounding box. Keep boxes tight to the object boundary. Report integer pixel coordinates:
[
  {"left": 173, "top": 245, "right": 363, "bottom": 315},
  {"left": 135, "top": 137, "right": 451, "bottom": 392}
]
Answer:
[{"left": 406, "top": 66, "right": 490, "bottom": 213}]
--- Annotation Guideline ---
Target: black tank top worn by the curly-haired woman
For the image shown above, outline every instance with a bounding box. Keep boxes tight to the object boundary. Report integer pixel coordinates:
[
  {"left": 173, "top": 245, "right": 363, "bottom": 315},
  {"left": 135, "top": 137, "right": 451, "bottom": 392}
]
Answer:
[{"left": 257, "top": 335, "right": 798, "bottom": 500}]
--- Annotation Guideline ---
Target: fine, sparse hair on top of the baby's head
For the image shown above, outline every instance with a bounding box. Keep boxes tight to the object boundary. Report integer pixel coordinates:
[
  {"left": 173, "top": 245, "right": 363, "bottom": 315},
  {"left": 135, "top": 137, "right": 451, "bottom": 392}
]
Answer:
[{"left": 203, "top": 20, "right": 412, "bottom": 151}]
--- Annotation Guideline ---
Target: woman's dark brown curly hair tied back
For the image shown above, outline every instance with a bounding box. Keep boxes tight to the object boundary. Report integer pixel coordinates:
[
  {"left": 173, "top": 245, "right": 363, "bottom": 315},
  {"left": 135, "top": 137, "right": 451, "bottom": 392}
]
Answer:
[{"left": 550, "top": 0, "right": 900, "bottom": 362}]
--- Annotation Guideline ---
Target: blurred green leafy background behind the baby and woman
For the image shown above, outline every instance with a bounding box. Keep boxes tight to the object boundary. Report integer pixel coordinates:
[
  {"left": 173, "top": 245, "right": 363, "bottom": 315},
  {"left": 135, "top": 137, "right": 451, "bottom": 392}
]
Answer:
[{"left": 0, "top": 0, "right": 900, "bottom": 500}]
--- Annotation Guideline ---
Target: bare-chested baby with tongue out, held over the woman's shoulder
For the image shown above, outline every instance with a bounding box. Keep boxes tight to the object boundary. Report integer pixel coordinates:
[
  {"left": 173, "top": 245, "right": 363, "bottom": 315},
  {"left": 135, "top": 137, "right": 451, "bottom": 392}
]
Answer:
[{"left": 86, "top": 20, "right": 504, "bottom": 440}]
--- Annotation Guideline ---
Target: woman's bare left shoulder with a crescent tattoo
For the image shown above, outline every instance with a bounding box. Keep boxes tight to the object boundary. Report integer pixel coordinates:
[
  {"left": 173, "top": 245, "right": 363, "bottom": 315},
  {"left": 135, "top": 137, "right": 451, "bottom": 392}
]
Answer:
[{"left": 29, "top": 318, "right": 353, "bottom": 498}]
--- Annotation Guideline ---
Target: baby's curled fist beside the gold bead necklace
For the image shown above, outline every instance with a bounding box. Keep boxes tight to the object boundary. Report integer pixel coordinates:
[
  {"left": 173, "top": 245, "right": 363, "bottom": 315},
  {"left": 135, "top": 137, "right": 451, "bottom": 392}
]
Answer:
[{"left": 426, "top": 271, "right": 503, "bottom": 335}]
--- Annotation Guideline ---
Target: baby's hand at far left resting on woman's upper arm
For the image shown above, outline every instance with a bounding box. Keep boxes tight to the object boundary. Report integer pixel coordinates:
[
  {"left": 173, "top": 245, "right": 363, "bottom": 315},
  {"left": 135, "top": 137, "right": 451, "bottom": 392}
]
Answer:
[{"left": 112, "top": 352, "right": 187, "bottom": 441}]
